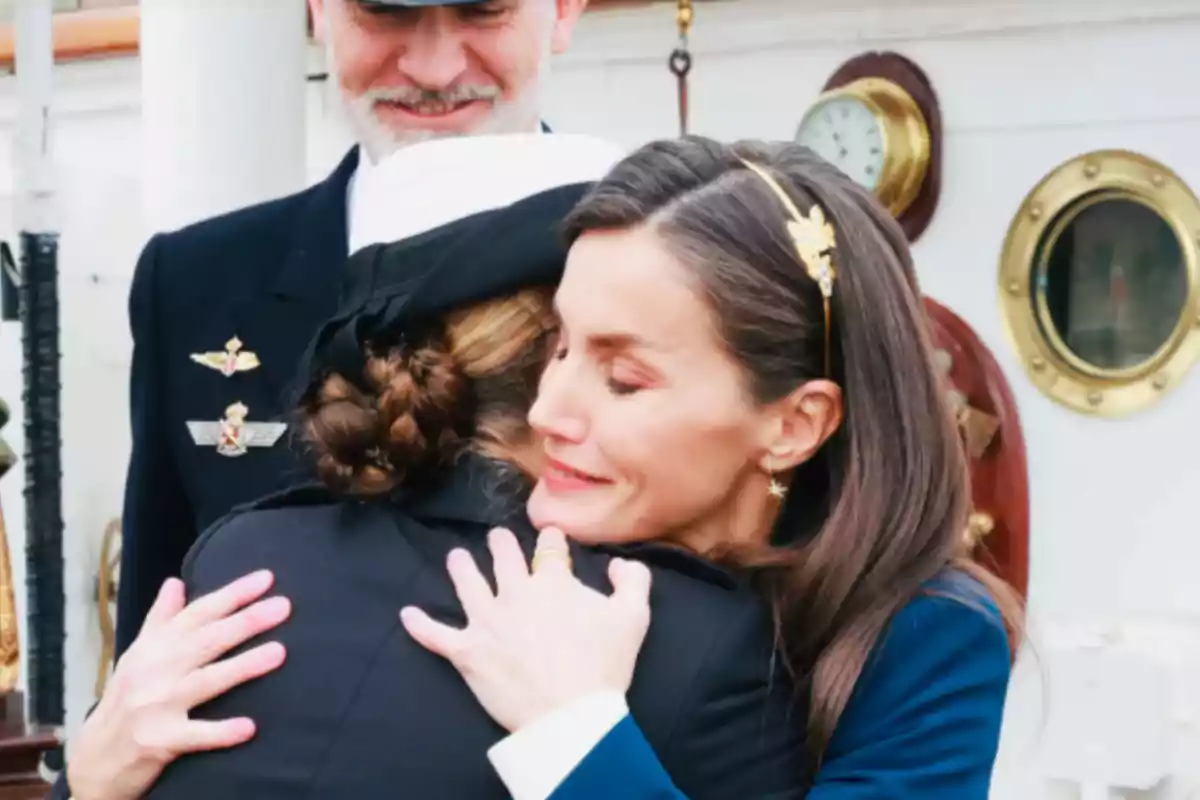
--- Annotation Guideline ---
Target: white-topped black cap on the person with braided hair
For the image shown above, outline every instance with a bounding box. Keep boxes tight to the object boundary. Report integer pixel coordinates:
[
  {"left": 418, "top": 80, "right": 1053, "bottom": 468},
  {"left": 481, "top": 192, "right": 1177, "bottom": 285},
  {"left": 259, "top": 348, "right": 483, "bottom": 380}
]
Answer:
[{"left": 298, "top": 133, "right": 625, "bottom": 397}]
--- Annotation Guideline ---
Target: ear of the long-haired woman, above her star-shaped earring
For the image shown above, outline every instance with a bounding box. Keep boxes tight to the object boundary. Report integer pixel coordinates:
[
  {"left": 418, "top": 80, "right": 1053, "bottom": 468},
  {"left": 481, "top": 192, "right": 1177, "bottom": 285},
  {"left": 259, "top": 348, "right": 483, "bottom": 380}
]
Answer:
[{"left": 760, "top": 380, "right": 844, "bottom": 474}]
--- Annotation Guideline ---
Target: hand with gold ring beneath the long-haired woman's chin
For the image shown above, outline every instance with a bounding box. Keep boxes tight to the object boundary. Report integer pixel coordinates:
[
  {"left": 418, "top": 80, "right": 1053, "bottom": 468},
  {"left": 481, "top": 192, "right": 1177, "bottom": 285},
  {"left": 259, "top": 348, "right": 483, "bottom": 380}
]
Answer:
[{"left": 401, "top": 529, "right": 650, "bottom": 732}]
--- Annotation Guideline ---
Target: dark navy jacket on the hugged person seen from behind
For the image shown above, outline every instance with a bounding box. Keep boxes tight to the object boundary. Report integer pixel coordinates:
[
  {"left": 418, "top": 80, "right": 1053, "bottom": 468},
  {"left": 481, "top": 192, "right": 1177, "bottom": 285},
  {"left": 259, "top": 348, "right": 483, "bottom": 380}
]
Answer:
[{"left": 146, "top": 459, "right": 805, "bottom": 800}]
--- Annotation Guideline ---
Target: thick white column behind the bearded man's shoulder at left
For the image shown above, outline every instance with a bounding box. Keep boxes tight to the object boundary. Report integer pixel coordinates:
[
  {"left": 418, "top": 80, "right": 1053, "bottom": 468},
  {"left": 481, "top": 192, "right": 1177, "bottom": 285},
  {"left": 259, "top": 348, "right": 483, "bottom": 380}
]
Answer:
[{"left": 140, "top": 0, "right": 306, "bottom": 231}]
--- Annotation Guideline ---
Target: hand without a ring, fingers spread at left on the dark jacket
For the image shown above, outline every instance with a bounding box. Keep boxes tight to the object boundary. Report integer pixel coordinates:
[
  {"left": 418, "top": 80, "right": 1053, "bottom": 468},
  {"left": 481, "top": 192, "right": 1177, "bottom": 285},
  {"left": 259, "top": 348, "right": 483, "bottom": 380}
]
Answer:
[{"left": 67, "top": 571, "right": 292, "bottom": 800}]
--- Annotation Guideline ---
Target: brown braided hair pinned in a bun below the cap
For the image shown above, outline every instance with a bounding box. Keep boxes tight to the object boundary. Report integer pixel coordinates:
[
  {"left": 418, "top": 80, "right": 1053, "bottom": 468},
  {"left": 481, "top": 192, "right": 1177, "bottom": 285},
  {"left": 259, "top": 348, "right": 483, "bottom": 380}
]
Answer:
[{"left": 299, "top": 288, "right": 554, "bottom": 497}]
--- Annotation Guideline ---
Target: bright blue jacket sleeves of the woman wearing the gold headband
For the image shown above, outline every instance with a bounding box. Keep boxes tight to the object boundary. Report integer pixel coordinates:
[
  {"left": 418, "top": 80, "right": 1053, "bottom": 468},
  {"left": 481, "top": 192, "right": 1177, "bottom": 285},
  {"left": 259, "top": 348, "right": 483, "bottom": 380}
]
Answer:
[{"left": 550, "top": 581, "right": 1009, "bottom": 800}]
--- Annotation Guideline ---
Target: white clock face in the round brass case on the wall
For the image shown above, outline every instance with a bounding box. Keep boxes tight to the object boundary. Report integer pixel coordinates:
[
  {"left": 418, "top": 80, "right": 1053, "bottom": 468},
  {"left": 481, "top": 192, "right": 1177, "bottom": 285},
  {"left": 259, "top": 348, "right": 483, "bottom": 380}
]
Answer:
[{"left": 796, "top": 97, "right": 886, "bottom": 191}]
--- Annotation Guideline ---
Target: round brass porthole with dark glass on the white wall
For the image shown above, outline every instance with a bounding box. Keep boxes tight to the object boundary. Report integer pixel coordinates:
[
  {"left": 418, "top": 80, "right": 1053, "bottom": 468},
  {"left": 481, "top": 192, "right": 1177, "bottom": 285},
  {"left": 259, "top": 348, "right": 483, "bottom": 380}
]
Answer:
[{"left": 1000, "top": 150, "right": 1200, "bottom": 416}]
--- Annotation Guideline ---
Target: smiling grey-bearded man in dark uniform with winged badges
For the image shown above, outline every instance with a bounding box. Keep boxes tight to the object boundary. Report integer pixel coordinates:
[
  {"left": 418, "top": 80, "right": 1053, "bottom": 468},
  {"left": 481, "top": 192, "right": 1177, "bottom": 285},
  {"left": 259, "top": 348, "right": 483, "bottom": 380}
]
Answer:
[{"left": 116, "top": 0, "right": 586, "bottom": 656}]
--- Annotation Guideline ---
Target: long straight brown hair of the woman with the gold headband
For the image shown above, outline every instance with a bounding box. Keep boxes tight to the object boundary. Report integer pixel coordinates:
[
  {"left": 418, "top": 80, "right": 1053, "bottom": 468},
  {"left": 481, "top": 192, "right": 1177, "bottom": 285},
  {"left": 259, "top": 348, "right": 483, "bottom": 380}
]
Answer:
[{"left": 566, "top": 137, "right": 1020, "bottom": 770}]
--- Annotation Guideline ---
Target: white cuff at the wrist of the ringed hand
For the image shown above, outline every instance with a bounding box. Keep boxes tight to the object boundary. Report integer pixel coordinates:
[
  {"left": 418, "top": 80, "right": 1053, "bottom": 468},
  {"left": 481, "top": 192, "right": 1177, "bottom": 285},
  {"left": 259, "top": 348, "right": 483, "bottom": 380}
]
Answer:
[{"left": 487, "top": 692, "right": 629, "bottom": 800}]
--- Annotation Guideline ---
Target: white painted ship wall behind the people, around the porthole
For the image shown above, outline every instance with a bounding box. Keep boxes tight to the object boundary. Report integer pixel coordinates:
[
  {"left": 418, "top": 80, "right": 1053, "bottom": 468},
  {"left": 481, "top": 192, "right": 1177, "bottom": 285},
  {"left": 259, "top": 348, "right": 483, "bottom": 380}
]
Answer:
[{"left": 0, "top": 0, "right": 1200, "bottom": 800}]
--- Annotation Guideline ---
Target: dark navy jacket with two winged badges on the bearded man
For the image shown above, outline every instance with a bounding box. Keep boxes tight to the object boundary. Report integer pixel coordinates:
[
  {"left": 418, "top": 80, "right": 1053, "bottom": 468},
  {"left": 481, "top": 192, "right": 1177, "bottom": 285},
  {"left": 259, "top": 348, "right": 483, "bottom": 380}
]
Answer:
[{"left": 116, "top": 149, "right": 358, "bottom": 655}]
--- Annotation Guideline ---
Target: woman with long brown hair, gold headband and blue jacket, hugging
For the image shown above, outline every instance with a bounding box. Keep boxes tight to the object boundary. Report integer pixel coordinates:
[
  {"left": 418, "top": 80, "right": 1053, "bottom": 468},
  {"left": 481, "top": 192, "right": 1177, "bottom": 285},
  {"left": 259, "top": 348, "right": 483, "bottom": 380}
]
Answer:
[{"left": 406, "top": 138, "right": 1021, "bottom": 800}]
